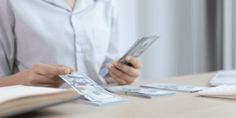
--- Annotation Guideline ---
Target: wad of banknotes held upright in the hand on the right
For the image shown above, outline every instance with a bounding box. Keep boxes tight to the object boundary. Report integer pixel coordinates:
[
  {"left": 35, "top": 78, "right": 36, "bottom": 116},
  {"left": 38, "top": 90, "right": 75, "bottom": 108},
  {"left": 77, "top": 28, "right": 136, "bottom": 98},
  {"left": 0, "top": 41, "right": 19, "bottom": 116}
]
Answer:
[{"left": 103, "top": 36, "right": 159, "bottom": 77}]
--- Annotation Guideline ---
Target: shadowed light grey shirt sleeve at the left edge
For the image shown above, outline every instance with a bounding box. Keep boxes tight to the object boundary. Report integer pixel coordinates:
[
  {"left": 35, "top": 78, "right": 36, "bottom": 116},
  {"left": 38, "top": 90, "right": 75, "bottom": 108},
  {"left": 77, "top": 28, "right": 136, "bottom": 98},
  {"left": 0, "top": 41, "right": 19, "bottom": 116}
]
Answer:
[{"left": 0, "top": 0, "right": 15, "bottom": 77}]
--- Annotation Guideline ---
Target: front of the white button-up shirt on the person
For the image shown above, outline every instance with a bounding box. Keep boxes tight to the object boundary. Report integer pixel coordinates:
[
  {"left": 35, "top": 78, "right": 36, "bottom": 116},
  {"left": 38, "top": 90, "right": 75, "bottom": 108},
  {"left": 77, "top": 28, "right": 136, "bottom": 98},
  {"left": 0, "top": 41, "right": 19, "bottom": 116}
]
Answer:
[{"left": 0, "top": 0, "right": 119, "bottom": 83}]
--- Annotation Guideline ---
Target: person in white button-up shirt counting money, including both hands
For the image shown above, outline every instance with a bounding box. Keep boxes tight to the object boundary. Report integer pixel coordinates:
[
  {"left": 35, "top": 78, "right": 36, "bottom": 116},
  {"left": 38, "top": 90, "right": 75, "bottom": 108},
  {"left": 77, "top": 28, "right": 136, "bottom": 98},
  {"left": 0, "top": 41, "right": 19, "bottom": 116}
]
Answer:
[{"left": 0, "top": 0, "right": 141, "bottom": 87}]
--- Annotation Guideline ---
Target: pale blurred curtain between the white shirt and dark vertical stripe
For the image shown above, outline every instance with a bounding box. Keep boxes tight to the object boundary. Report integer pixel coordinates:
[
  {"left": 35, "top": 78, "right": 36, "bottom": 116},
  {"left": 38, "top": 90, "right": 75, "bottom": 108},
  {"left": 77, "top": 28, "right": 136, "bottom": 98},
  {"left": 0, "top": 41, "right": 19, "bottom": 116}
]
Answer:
[{"left": 118, "top": 0, "right": 214, "bottom": 79}]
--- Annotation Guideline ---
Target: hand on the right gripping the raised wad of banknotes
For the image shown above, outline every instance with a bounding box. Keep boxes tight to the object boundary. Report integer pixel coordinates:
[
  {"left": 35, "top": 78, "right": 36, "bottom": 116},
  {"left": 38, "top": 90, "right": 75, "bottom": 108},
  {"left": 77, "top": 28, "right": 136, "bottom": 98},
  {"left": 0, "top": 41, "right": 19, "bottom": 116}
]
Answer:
[{"left": 107, "top": 56, "right": 141, "bottom": 85}]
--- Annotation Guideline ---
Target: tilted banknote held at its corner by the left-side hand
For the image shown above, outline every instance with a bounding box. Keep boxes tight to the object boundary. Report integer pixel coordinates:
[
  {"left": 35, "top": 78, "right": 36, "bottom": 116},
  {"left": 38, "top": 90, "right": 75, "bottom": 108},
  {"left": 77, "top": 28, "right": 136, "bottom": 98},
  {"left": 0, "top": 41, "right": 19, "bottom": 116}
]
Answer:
[{"left": 60, "top": 72, "right": 126, "bottom": 106}]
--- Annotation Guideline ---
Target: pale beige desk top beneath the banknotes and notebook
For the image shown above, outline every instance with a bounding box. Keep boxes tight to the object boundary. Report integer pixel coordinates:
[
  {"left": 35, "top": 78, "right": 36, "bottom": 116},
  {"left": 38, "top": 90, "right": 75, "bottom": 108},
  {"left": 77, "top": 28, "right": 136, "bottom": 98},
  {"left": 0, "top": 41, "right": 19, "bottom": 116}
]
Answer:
[{"left": 13, "top": 74, "right": 236, "bottom": 118}]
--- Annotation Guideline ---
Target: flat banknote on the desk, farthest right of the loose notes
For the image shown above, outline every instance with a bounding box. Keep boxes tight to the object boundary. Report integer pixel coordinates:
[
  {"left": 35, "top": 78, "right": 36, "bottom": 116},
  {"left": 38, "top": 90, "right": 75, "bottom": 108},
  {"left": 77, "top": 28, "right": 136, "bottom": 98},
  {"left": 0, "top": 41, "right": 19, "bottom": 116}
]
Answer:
[{"left": 141, "top": 83, "right": 205, "bottom": 93}]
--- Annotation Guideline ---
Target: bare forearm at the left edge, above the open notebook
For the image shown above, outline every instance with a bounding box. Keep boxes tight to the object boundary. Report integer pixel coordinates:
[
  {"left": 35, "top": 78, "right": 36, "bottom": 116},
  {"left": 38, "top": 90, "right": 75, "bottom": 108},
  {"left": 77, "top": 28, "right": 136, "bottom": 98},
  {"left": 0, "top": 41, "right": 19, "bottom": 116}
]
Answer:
[{"left": 0, "top": 71, "right": 28, "bottom": 87}]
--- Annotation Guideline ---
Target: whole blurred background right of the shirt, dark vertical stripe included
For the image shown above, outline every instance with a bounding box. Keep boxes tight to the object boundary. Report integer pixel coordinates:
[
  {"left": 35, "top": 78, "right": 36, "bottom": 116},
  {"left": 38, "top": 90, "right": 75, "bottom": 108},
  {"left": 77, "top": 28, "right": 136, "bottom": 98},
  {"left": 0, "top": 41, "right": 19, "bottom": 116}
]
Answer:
[{"left": 117, "top": 0, "right": 236, "bottom": 79}]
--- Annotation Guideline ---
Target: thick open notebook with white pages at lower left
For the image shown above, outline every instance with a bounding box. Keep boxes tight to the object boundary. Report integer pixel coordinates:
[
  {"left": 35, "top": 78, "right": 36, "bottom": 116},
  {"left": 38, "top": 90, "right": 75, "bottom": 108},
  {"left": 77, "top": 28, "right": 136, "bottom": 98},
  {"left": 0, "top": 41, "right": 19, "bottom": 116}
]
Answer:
[{"left": 0, "top": 85, "right": 79, "bottom": 118}]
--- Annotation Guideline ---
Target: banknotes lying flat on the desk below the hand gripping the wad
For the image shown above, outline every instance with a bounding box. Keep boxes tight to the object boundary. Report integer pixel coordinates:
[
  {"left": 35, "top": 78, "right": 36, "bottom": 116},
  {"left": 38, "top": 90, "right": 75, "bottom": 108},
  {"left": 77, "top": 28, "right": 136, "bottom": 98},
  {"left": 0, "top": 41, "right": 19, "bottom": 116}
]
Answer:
[{"left": 105, "top": 85, "right": 175, "bottom": 98}]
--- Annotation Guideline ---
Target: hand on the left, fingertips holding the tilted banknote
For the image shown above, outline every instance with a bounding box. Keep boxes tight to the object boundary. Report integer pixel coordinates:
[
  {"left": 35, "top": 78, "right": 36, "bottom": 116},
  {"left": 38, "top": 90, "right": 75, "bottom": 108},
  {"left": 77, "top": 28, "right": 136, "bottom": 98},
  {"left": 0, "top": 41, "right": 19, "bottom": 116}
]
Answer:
[{"left": 21, "top": 64, "right": 73, "bottom": 88}]
